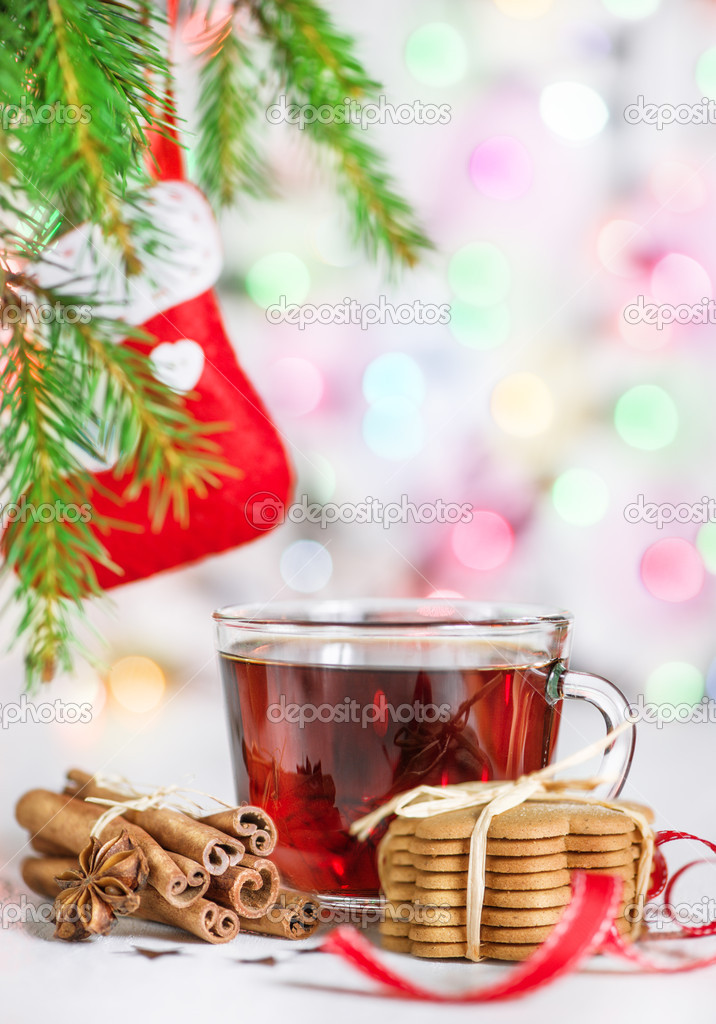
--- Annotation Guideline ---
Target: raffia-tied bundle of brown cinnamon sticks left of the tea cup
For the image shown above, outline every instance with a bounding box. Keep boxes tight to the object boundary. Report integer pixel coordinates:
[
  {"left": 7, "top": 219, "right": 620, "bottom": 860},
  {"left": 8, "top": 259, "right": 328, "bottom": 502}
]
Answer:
[{"left": 15, "top": 770, "right": 319, "bottom": 943}]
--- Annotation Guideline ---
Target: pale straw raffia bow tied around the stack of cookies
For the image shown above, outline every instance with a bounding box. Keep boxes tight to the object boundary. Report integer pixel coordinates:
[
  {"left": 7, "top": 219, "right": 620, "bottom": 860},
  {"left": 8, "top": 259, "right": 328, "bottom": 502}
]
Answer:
[{"left": 350, "top": 722, "right": 654, "bottom": 961}]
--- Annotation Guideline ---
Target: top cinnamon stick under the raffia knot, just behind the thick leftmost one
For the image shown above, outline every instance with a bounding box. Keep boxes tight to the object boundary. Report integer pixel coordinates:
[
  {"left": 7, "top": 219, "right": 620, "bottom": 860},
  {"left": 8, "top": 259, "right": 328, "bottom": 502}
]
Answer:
[{"left": 68, "top": 769, "right": 245, "bottom": 874}]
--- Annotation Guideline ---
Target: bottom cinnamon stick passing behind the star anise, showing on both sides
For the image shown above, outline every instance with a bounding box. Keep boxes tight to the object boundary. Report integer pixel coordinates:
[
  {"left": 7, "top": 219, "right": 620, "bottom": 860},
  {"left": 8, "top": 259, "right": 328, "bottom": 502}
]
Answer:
[{"left": 22, "top": 857, "right": 240, "bottom": 943}]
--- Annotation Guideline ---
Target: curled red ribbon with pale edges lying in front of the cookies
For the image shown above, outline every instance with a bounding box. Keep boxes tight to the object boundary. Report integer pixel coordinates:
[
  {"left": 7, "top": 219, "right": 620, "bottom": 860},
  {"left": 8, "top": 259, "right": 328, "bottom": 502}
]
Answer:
[{"left": 320, "top": 831, "right": 716, "bottom": 1004}]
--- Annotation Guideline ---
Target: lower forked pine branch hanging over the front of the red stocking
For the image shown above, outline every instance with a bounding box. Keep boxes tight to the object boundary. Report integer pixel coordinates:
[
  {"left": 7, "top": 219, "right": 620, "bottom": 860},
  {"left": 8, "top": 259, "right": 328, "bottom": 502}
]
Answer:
[{"left": 0, "top": 272, "right": 237, "bottom": 686}]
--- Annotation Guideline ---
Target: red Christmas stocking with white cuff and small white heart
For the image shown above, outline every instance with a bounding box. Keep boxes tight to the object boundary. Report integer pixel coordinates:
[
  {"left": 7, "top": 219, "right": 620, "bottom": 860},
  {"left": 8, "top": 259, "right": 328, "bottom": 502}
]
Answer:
[{"left": 30, "top": 139, "right": 292, "bottom": 588}]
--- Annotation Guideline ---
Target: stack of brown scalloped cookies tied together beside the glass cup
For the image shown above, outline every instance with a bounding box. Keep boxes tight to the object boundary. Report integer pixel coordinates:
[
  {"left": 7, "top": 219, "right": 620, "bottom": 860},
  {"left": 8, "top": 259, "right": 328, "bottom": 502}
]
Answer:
[{"left": 379, "top": 802, "right": 650, "bottom": 961}]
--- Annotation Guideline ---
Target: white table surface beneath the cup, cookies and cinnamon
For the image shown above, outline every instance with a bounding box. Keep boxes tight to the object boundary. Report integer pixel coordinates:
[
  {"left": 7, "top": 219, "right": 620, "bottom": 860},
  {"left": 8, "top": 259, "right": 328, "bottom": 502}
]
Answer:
[{"left": 0, "top": 670, "right": 716, "bottom": 1024}]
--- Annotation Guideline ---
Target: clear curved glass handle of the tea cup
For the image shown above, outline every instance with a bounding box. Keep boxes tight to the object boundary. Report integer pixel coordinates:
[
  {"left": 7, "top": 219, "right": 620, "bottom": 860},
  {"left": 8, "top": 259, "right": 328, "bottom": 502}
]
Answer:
[{"left": 547, "top": 663, "right": 636, "bottom": 798}]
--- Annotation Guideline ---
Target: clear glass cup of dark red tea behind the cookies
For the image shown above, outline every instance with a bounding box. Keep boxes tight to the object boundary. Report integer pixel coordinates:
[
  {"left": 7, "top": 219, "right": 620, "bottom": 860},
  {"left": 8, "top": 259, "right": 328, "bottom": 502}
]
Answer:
[{"left": 214, "top": 599, "right": 633, "bottom": 906}]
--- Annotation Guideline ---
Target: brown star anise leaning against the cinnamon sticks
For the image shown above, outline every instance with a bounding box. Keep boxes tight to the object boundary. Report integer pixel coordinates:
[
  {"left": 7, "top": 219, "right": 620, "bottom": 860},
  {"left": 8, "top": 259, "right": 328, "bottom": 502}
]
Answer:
[{"left": 54, "top": 829, "right": 149, "bottom": 942}]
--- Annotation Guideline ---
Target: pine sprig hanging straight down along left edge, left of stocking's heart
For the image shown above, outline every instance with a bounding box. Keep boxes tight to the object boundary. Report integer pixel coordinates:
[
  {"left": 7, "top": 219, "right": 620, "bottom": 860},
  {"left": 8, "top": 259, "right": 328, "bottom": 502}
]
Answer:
[{"left": 0, "top": 325, "right": 113, "bottom": 687}]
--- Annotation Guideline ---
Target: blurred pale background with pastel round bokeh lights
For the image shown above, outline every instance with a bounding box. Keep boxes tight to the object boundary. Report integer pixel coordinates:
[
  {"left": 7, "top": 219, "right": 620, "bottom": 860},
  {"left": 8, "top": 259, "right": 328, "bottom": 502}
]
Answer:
[{"left": 3, "top": 0, "right": 716, "bottom": 774}]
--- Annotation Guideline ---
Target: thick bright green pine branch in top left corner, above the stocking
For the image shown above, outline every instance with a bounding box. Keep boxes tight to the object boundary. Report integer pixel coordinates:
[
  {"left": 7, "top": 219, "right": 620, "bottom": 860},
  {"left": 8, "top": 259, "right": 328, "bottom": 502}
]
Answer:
[{"left": 5, "top": 0, "right": 168, "bottom": 264}]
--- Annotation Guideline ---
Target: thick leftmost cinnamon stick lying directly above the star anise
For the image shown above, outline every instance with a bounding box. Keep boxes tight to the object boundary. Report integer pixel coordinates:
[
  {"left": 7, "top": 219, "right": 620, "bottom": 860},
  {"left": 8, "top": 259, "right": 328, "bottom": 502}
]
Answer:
[{"left": 15, "top": 790, "right": 203, "bottom": 906}]
